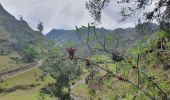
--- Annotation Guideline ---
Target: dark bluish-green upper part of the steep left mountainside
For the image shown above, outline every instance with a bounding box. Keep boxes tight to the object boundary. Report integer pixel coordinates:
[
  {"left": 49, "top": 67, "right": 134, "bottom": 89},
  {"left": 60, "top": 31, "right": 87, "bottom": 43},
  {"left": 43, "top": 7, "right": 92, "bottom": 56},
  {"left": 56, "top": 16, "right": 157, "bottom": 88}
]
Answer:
[{"left": 0, "top": 4, "right": 46, "bottom": 49}]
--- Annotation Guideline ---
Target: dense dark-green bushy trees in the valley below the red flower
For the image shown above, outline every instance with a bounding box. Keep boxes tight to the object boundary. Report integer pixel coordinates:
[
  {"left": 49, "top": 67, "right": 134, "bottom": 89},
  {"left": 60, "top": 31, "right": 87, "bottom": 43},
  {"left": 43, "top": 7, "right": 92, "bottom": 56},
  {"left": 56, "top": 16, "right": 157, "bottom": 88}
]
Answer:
[{"left": 42, "top": 45, "right": 81, "bottom": 100}]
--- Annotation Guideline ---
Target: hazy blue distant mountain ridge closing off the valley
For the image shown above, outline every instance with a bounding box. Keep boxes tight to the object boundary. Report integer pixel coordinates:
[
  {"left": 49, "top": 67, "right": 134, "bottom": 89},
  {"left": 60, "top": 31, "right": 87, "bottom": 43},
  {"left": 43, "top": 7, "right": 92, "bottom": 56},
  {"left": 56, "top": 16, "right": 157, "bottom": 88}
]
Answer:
[{"left": 46, "top": 23, "right": 159, "bottom": 47}]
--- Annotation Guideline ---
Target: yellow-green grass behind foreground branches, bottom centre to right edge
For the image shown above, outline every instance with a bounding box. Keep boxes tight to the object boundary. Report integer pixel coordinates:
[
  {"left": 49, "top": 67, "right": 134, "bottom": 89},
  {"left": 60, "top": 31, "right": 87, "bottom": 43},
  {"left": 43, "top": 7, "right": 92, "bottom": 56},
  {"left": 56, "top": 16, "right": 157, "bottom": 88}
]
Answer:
[{"left": 72, "top": 51, "right": 170, "bottom": 100}]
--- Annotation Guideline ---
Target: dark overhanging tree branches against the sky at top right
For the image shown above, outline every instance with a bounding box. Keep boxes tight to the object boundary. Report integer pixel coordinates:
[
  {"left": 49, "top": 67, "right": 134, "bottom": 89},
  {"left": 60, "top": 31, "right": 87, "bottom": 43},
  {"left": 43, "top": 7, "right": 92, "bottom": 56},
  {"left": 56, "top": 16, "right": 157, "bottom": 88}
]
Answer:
[{"left": 86, "top": 0, "right": 170, "bottom": 23}]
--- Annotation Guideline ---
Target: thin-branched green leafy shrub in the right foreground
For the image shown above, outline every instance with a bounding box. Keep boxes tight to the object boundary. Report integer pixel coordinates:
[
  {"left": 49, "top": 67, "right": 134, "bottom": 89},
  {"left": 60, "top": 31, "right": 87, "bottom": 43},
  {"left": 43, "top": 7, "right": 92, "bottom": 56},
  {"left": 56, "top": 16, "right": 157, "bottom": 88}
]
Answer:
[{"left": 74, "top": 24, "right": 168, "bottom": 100}]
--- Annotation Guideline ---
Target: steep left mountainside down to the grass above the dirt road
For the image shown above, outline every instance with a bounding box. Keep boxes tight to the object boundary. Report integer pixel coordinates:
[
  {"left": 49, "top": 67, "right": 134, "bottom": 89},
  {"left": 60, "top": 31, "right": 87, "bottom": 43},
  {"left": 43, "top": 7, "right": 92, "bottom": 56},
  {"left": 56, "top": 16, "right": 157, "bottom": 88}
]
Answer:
[{"left": 0, "top": 4, "right": 48, "bottom": 74}]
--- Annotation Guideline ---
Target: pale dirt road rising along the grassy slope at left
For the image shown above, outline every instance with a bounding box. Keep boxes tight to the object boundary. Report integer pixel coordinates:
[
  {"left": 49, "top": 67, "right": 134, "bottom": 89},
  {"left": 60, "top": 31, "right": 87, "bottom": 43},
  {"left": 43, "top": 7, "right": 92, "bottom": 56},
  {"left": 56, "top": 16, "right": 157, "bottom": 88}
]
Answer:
[{"left": 0, "top": 59, "right": 44, "bottom": 80}]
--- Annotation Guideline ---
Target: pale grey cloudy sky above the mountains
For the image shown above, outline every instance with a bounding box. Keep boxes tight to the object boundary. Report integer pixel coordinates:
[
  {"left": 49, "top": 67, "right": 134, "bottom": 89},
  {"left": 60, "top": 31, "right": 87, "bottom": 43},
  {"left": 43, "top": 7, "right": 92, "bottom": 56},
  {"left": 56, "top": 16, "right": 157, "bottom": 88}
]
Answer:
[{"left": 0, "top": 0, "right": 149, "bottom": 34}]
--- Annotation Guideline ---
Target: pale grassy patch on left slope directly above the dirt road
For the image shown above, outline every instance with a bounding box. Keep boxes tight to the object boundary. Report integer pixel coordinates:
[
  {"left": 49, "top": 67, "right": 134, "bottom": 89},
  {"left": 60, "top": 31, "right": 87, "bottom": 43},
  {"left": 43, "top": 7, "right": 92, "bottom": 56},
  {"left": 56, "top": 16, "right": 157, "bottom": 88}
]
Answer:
[{"left": 0, "top": 27, "right": 27, "bottom": 73}]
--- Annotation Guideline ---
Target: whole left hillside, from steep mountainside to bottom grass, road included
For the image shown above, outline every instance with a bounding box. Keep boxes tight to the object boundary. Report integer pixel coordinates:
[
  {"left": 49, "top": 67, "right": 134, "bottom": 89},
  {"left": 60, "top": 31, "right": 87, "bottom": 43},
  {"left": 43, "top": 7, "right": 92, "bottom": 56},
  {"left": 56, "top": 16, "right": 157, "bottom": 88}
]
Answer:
[{"left": 0, "top": 4, "right": 56, "bottom": 100}]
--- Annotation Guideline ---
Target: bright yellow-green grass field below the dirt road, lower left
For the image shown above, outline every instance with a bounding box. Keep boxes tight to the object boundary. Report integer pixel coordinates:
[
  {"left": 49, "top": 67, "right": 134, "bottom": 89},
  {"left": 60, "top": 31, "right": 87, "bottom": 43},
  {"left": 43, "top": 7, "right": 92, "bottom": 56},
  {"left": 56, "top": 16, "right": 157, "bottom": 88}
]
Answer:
[{"left": 0, "top": 68, "right": 56, "bottom": 100}]
